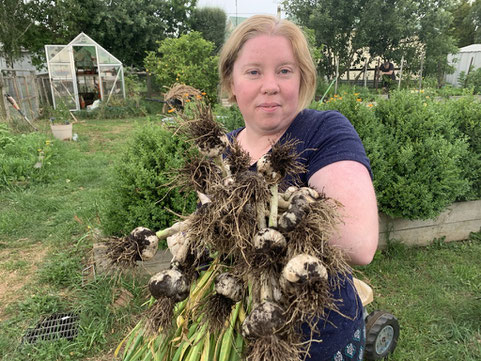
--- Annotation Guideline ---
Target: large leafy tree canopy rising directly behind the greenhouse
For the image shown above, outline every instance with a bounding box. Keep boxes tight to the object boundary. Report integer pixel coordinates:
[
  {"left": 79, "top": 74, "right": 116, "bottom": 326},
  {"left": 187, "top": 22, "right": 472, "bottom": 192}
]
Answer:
[{"left": 23, "top": 0, "right": 197, "bottom": 67}]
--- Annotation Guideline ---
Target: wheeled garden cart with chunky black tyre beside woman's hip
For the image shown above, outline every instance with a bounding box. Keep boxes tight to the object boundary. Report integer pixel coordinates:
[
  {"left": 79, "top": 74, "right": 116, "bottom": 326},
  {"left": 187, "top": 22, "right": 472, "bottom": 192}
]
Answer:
[{"left": 354, "top": 278, "right": 399, "bottom": 360}]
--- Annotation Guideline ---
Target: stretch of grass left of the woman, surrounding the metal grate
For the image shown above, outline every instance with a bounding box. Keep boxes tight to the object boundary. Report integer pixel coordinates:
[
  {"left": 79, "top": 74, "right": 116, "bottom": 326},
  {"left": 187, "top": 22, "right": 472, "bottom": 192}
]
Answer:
[{"left": 0, "top": 119, "right": 151, "bottom": 361}]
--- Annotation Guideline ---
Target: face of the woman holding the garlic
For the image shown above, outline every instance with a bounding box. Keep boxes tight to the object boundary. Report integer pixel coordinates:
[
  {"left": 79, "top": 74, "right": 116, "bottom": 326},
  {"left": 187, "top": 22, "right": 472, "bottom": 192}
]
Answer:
[{"left": 232, "top": 35, "right": 301, "bottom": 135}]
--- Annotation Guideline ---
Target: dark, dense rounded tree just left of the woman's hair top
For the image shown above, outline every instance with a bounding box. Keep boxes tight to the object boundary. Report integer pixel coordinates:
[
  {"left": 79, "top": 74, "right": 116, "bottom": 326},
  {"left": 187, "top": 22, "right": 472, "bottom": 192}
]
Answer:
[{"left": 191, "top": 7, "right": 227, "bottom": 52}]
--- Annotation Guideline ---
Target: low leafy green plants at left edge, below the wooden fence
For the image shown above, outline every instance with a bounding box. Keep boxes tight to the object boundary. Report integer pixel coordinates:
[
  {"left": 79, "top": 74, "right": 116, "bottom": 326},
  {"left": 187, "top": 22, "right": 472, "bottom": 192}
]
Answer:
[{"left": 0, "top": 123, "right": 58, "bottom": 188}]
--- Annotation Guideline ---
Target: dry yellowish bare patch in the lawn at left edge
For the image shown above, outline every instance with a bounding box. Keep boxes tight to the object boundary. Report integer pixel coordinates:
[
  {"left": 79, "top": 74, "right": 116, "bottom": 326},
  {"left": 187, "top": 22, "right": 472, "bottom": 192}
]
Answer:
[{"left": 0, "top": 243, "right": 48, "bottom": 321}]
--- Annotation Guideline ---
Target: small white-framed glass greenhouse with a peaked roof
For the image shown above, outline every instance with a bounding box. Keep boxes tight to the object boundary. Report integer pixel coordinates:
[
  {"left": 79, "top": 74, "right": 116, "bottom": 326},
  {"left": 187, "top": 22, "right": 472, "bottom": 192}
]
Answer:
[{"left": 45, "top": 33, "right": 125, "bottom": 110}]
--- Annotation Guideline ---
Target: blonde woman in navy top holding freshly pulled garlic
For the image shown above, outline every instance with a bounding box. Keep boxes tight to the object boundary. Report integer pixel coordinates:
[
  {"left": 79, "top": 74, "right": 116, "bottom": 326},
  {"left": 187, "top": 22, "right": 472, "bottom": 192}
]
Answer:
[{"left": 219, "top": 15, "right": 378, "bottom": 360}]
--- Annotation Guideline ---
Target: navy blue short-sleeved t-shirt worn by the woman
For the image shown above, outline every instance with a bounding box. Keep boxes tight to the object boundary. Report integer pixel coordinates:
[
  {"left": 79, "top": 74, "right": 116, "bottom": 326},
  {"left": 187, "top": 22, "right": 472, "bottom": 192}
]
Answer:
[{"left": 229, "top": 109, "right": 372, "bottom": 361}]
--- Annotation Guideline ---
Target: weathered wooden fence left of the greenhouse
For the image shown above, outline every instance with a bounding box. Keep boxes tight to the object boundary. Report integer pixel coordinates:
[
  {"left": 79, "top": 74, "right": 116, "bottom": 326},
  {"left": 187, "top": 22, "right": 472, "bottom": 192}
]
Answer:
[{"left": 0, "top": 69, "right": 52, "bottom": 120}]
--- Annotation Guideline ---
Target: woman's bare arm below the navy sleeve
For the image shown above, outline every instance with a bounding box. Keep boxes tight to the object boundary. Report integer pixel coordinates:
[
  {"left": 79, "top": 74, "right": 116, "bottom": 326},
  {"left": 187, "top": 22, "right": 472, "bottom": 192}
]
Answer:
[{"left": 309, "top": 161, "right": 379, "bottom": 265}]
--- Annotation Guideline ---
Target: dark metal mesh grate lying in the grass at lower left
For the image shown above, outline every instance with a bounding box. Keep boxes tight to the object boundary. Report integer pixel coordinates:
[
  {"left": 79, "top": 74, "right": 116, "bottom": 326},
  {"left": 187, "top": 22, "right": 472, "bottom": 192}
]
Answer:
[{"left": 22, "top": 313, "right": 79, "bottom": 343}]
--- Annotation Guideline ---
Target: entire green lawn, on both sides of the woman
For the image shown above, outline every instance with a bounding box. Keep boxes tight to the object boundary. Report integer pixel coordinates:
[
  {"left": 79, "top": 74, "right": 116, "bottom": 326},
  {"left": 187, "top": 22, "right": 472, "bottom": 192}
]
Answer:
[{"left": 0, "top": 118, "right": 481, "bottom": 361}]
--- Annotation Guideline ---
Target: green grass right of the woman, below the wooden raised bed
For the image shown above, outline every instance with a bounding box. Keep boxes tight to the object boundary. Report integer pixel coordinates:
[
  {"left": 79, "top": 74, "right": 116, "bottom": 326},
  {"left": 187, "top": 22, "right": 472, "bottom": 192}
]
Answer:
[{"left": 362, "top": 234, "right": 481, "bottom": 361}]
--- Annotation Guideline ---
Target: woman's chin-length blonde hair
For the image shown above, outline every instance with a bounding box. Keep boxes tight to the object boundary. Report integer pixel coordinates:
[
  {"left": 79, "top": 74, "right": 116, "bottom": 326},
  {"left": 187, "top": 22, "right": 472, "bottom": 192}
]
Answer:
[{"left": 219, "top": 15, "right": 316, "bottom": 111}]
